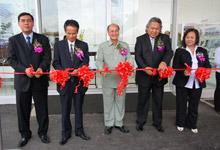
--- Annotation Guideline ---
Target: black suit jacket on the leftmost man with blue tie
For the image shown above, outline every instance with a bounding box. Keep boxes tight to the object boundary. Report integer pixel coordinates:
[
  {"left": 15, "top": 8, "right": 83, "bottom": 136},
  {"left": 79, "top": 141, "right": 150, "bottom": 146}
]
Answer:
[{"left": 8, "top": 32, "right": 51, "bottom": 92}]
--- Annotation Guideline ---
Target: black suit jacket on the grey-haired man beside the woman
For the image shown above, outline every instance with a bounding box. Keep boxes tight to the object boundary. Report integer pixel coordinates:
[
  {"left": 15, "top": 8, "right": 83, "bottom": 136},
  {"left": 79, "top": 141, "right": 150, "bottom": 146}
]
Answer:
[{"left": 135, "top": 33, "right": 173, "bottom": 87}]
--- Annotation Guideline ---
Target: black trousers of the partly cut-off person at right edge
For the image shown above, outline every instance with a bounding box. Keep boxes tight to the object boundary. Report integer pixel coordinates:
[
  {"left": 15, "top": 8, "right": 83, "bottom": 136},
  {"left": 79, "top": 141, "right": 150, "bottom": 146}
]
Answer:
[{"left": 214, "top": 72, "right": 220, "bottom": 112}]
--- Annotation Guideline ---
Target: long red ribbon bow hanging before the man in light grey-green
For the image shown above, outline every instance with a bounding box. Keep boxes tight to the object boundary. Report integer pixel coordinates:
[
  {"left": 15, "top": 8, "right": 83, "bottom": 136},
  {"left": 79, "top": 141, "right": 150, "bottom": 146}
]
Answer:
[{"left": 115, "top": 61, "right": 134, "bottom": 96}]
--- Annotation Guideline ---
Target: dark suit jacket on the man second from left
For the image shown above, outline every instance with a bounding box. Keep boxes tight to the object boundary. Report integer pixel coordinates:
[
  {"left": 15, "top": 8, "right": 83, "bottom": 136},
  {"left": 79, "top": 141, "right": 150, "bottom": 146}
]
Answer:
[{"left": 53, "top": 39, "right": 89, "bottom": 95}]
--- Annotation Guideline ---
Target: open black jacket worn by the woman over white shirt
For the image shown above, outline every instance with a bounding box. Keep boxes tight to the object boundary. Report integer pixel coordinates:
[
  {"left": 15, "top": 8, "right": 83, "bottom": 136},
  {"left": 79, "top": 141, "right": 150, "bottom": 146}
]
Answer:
[{"left": 173, "top": 47, "right": 211, "bottom": 88}]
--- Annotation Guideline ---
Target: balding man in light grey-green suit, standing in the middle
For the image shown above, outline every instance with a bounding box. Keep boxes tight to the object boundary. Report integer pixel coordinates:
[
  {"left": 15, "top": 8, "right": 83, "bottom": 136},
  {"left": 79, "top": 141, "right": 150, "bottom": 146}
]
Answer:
[{"left": 96, "top": 24, "right": 134, "bottom": 134}]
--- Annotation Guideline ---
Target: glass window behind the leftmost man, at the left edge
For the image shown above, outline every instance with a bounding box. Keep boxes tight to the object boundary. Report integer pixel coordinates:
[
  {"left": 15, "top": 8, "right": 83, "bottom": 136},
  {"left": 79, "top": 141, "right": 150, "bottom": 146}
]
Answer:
[{"left": 0, "top": 0, "right": 35, "bottom": 96}]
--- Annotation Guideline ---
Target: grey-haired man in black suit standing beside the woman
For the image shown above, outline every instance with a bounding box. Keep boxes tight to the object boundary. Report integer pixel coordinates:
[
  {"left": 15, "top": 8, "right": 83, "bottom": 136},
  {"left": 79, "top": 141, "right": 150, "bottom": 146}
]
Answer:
[{"left": 135, "top": 17, "right": 173, "bottom": 133}]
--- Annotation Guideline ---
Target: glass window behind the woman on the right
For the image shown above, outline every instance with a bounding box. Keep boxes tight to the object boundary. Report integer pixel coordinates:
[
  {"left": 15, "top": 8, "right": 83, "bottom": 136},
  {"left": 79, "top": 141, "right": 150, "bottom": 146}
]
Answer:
[{"left": 178, "top": 0, "right": 220, "bottom": 93}]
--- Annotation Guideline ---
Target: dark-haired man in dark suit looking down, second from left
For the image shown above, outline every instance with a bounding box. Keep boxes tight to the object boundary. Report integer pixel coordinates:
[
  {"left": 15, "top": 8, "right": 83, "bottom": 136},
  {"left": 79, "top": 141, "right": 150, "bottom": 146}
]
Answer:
[{"left": 53, "top": 20, "right": 90, "bottom": 145}]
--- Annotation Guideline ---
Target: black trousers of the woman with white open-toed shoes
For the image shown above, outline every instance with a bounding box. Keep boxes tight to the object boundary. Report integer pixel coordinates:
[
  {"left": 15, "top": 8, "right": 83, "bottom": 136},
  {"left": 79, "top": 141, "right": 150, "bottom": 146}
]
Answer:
[{"left": 176, "top": 86, "right": 202, "bottom": 129}]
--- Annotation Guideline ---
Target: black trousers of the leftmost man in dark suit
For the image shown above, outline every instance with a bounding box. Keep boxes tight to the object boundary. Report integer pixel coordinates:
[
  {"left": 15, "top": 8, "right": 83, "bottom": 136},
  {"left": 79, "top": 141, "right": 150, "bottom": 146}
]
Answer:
[{"left": 16, "top": 88, "right": 49, "bottom": 138}]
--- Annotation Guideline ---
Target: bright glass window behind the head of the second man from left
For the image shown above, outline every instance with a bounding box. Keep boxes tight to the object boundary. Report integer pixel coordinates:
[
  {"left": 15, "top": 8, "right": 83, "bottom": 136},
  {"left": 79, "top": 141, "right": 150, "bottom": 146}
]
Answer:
[{"left": 41, "top": 0, "right": 106, "bottom": 52}]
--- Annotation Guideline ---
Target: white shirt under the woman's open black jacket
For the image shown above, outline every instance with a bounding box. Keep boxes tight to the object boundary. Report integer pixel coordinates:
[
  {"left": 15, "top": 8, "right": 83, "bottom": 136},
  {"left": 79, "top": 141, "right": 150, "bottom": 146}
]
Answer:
[{"left": 185, "top": 46, "right": 200, "bottom": 89}]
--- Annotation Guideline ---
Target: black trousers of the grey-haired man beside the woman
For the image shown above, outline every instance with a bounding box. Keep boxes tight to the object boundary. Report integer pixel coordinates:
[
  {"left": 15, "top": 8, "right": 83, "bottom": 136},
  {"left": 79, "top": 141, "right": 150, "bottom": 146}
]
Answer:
[{"left": 136, "top": 82, "right": 164, "bottom": 126}]
